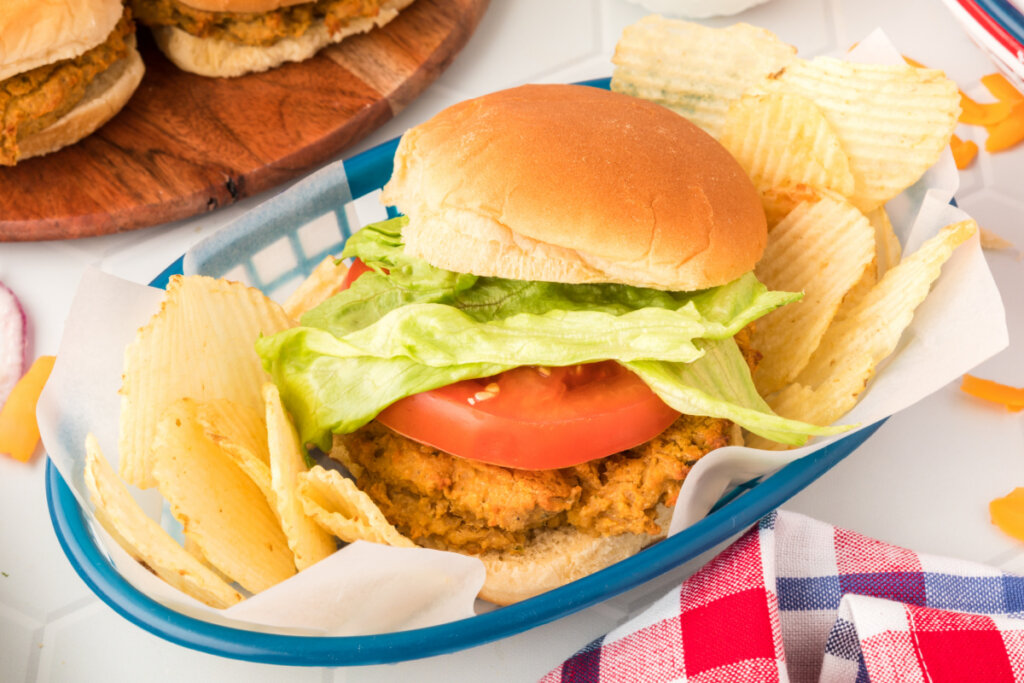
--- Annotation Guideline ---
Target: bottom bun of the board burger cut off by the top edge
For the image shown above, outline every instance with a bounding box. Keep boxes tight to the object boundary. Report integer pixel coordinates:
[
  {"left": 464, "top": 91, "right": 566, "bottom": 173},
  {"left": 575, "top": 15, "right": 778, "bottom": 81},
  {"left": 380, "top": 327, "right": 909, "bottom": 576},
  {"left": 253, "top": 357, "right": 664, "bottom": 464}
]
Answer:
[{"left": 153, "top": 0, "right": 413, "bottom": 78}]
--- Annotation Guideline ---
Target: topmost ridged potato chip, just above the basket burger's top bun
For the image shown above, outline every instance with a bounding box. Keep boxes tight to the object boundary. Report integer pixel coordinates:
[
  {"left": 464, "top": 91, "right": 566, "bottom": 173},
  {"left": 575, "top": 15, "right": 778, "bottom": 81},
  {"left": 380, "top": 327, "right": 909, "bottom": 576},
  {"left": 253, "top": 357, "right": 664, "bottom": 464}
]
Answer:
[{"left": 611, "top": 15, "right": 797, "bottom": 137}]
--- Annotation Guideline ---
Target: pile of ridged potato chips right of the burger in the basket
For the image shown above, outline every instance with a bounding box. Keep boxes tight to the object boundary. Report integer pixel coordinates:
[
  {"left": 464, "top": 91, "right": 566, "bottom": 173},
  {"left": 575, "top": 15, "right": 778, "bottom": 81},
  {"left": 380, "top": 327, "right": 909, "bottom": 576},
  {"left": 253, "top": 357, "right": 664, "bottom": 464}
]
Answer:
[{"left": 611, "top": 15, "right": 977, "bottom": 449}]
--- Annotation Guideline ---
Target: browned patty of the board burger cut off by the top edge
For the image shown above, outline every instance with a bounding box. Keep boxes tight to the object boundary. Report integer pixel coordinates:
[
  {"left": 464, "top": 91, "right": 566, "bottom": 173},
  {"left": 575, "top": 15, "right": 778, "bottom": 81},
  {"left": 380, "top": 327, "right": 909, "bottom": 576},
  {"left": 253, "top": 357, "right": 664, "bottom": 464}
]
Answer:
[{"left": 132, "top": 0, "right": 381, "bottom": 46}]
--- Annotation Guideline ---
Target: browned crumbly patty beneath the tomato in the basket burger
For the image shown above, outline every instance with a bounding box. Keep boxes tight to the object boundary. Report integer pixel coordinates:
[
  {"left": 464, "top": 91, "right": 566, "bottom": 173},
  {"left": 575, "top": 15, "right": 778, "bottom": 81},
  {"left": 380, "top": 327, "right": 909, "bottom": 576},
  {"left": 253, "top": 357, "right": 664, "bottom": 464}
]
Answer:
[{"left": 334, "top": 415, "right": 732, "bottom": 553}]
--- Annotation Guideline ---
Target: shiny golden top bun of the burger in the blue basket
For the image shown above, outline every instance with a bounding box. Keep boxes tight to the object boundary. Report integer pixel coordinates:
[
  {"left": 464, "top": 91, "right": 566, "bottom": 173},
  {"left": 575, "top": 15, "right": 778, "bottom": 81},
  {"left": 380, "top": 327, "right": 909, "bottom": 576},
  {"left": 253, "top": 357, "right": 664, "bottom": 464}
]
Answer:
[{"left": 382, "top": 85, "right": 767, "bottom": 291}]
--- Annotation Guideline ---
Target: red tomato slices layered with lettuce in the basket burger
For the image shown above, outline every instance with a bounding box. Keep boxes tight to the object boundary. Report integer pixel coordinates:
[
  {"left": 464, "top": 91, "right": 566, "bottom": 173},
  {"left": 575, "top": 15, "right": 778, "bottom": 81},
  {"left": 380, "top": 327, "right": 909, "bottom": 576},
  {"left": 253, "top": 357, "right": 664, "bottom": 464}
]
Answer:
[{"left": 339, "top": 259, "right": 679, "bottom": 470}]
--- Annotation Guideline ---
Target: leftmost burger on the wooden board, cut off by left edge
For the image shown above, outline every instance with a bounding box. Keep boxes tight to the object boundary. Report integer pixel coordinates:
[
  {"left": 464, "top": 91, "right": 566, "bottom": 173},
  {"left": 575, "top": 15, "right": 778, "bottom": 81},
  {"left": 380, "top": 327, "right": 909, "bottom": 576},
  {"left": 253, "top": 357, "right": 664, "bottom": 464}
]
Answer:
[{"left": 0, "top": 0, "right": 144, "bottom": 166}]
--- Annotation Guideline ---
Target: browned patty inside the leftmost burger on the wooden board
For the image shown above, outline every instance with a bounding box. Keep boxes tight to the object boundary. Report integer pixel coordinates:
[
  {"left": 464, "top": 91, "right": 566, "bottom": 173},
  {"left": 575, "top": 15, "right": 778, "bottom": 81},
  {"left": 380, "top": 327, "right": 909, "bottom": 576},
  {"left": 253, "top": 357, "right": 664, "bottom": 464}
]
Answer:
[{"left": 0, "top": 8, "right": 134, "bottom": 165}]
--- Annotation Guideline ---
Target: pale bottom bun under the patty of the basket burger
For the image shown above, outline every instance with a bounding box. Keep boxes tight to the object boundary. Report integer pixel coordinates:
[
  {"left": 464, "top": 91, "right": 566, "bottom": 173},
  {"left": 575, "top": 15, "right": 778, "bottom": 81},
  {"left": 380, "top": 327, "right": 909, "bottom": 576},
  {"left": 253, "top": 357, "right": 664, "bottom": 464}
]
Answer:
[{"left": 477, "top": 505, "right": 672, "bottom": 605}]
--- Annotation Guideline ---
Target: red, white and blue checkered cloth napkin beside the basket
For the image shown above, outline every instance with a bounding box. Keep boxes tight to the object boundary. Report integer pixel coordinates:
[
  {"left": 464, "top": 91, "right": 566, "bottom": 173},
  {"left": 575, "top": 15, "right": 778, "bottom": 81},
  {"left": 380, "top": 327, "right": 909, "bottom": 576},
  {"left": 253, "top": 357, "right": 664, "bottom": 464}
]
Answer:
[{"left": 544, "top": 512, "right": 1024, "bottom": 683}]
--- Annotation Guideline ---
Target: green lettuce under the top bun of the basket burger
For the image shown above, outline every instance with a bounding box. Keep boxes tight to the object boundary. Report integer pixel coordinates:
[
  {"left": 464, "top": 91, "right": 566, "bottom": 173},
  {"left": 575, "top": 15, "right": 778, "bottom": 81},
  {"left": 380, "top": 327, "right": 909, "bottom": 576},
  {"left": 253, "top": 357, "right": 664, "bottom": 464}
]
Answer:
[{"left": 257, "top": 217, "right": 836, "bottom": 449}]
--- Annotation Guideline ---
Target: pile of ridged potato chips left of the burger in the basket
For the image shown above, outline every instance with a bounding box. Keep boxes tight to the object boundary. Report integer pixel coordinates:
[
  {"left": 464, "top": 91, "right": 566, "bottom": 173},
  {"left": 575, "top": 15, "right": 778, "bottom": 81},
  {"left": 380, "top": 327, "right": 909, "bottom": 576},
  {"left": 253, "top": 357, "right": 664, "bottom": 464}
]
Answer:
[{"left": 85, "top": 274, "right": 413, "bottom": 608}]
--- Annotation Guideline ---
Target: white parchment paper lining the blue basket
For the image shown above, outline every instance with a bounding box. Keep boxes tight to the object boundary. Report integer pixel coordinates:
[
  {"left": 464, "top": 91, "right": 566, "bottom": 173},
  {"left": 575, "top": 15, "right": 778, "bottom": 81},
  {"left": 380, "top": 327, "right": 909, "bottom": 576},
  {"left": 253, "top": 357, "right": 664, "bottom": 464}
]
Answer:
[{"left": 37, "top": 32, "right": 1009, "bottom": 635}]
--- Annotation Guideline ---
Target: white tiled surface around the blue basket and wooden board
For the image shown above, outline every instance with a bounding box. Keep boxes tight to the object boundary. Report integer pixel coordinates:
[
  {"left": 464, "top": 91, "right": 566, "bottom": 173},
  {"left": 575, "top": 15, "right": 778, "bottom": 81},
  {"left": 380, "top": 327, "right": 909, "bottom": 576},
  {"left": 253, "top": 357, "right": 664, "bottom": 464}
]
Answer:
[{"left": 0, "top": 0, "right": 1024, "bottom": 683}]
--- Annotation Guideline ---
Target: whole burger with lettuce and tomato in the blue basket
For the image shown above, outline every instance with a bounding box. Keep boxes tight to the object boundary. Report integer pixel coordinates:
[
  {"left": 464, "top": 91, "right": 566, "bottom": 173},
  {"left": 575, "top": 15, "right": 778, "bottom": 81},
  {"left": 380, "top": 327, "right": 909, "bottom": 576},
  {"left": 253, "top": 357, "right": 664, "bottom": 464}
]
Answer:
[{"left": 257, "top": 85, "right": 829, "bottom": 603}]
